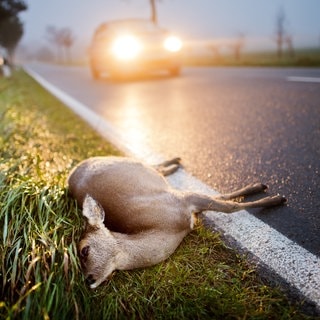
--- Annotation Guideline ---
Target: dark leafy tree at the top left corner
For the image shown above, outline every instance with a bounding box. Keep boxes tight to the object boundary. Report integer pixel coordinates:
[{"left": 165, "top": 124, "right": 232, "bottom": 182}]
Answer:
[{"left": 0, "top": 0, "right": 27, "bottom": 63}]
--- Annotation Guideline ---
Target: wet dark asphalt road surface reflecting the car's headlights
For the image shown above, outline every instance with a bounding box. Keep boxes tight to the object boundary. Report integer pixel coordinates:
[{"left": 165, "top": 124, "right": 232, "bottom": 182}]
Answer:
[{"left": 26, "top": 65, "right": 320, "bottom": 256}]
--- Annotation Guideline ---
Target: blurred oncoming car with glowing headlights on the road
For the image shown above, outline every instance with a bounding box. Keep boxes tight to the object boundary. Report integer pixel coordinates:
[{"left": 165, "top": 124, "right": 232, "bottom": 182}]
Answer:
[{"left": 89, "top": 19, "right": 182, "bottom": 79}]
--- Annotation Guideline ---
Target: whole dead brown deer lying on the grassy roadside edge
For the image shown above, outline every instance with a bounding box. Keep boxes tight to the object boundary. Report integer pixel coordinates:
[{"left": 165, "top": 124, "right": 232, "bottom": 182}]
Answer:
[{"left": 68, "top": 157, "right": 286, "bottom": 288}]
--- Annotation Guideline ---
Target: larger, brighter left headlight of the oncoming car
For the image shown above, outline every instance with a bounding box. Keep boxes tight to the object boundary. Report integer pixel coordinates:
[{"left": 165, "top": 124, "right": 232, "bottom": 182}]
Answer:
[{"left": 111, "top": 35, "right": 142, "bottom": 60}]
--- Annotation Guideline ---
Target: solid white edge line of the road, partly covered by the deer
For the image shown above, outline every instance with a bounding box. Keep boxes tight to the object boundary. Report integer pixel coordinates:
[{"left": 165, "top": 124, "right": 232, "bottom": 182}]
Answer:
[{"left": 25, "top": 67, "right": 320, "bottom": 310}]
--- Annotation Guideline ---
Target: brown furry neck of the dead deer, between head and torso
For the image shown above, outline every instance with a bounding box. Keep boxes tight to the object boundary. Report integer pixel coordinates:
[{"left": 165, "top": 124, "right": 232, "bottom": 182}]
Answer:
[{"left": 113, "top": 231, "right": 188, "bottom": 270}]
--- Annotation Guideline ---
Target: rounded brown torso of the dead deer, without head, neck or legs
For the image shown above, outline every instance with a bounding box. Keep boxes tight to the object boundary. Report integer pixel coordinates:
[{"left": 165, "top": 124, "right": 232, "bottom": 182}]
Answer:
[{"left": 68, "top": 157, "right": 194, "bottom": 234}]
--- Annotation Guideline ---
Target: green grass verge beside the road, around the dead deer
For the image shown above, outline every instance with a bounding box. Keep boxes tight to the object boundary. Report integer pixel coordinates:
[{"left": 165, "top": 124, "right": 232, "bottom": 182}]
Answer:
[{"left": 0, "top": 71, "right": 316, "bottom": 319}]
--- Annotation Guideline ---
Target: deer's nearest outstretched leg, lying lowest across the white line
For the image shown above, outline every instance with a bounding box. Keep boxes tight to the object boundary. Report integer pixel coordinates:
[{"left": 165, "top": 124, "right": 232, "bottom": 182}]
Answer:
[{"left": 186, "top": 193, "right": 287, "bottom": 213}]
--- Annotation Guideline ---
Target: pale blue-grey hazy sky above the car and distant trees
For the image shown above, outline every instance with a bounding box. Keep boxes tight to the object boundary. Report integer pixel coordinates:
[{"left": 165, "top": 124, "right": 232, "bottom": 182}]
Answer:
[{"left": 20, "top": 0, "right": 320, "bottom": 58}]
